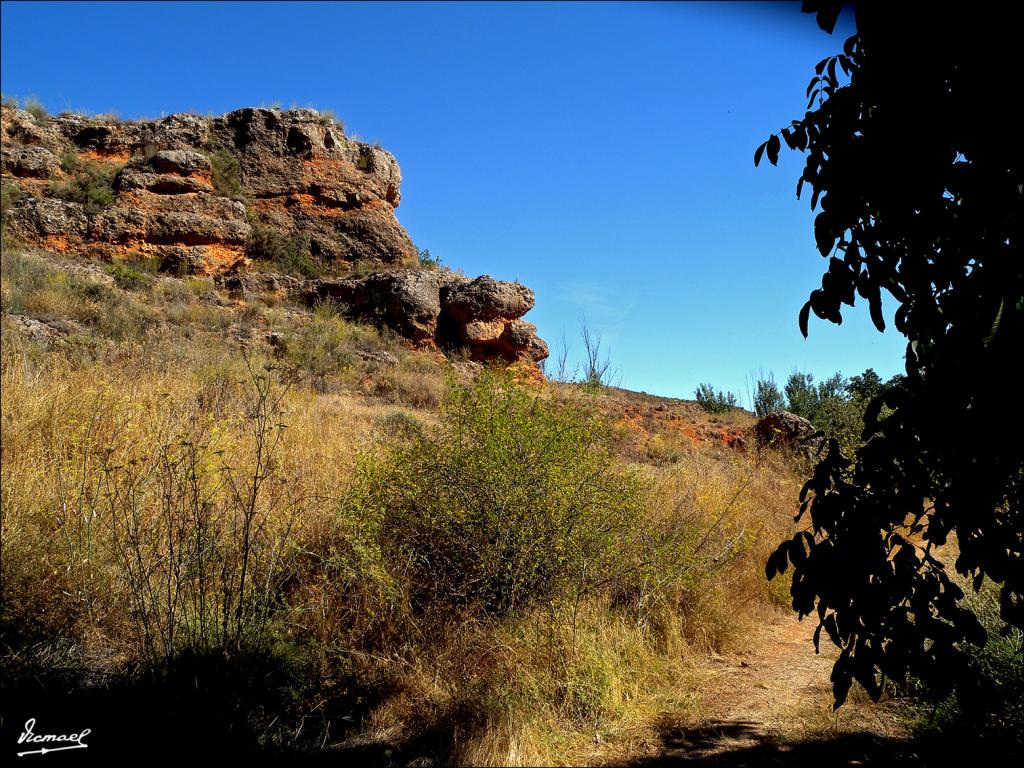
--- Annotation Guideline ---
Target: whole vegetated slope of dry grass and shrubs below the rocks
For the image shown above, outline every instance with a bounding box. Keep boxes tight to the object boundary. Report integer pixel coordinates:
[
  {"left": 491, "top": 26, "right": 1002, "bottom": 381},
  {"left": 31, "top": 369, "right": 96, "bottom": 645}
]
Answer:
[{"left": 0, "top": 244, "right": 796, "bottom": 764}]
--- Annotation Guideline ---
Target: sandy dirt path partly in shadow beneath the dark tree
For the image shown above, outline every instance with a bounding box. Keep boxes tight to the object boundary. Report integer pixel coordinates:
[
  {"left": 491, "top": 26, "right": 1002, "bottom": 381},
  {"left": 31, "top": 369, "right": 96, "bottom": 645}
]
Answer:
[{"left": 630, "top": 616, "right": 918, "bottom": 768}]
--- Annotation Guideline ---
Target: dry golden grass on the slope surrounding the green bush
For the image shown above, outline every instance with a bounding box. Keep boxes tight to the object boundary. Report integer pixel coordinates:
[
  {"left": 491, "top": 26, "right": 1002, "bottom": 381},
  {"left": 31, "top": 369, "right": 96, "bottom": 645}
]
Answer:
[{"left": 0, "top": 244, "right": 798, "bottom": 765}]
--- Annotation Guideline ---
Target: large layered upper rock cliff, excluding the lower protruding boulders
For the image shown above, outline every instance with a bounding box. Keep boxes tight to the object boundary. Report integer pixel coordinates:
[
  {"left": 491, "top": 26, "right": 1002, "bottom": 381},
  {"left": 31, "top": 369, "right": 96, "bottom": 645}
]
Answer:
[{"left": 0, "top": 106, "right": 417, "bottom": 273}]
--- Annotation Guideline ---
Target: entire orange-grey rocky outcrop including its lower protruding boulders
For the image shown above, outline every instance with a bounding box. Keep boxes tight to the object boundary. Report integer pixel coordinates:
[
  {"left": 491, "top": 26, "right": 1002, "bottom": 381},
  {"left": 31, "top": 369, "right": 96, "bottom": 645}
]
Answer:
[{"left": 0, "top": 105, "right": 548, "bottom": 366}]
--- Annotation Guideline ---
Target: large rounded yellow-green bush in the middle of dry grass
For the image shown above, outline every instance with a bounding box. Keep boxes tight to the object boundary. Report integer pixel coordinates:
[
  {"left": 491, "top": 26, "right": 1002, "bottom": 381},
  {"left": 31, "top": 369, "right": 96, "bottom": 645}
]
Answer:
[{"left": 351, "top": 374, "right": 644, "bottom": 615}]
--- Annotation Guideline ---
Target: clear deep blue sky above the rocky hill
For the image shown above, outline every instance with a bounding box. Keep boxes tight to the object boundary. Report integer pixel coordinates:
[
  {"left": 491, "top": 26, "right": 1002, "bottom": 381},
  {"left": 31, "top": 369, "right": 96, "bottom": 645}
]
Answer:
[{"left": 2, "top": 2, "right": 904, "bottom": 401}]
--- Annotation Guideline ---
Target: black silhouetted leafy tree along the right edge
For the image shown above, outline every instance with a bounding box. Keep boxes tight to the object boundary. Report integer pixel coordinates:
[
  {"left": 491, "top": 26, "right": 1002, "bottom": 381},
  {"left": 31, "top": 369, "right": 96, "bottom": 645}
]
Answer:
[{"left": 755, "top": 0, "right": 1024, "bottom": 708}]
